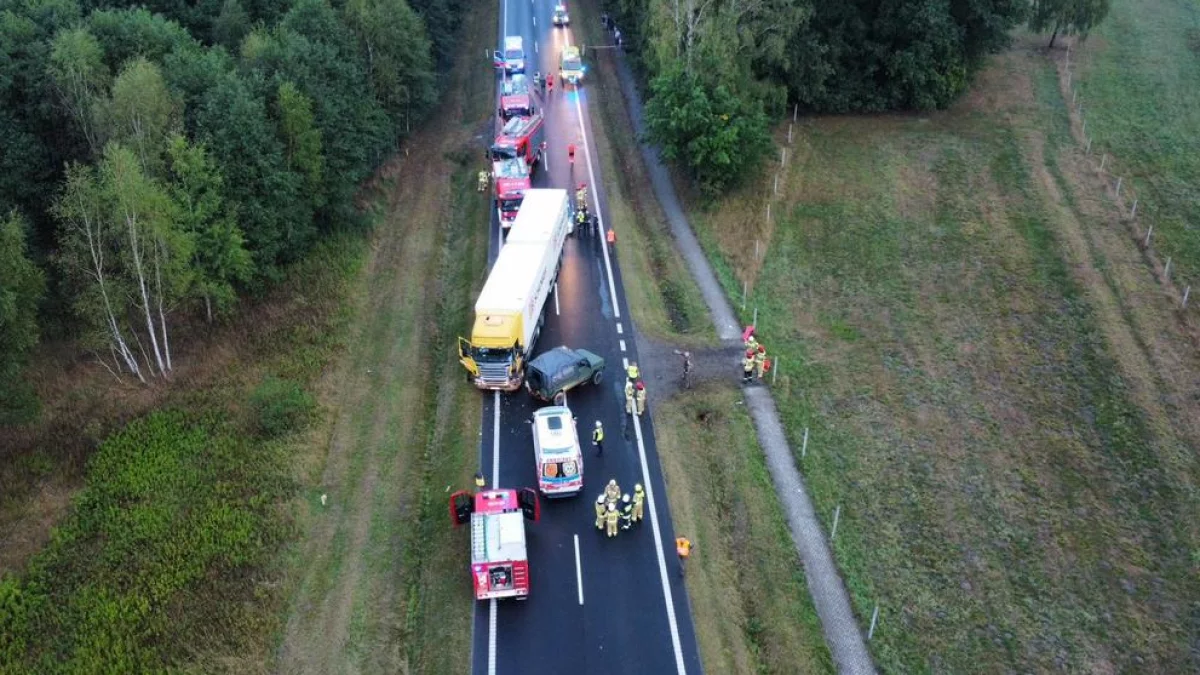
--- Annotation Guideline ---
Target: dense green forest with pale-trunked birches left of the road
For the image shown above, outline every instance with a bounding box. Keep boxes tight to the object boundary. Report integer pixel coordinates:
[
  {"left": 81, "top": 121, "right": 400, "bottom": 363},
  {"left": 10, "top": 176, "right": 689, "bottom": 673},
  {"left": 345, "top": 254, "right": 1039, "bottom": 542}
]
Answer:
[{"left": 0, "top": 0, "right": 461, "bottom": 424}]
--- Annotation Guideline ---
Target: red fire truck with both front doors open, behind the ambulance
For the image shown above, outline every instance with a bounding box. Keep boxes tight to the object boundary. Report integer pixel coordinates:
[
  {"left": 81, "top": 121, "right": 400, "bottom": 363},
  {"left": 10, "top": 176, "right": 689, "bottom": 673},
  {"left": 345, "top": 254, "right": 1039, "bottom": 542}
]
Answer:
[{"left": 450, "top": 488, "right": 541, "bottom": 601}]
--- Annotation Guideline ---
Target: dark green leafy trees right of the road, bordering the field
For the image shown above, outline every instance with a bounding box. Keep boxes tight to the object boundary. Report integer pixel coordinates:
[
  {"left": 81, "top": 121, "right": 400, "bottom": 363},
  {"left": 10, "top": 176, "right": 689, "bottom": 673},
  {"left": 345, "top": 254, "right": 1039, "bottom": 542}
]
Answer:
[{"left": 628, "top": 0, "right": 1109, "bottom": 192}]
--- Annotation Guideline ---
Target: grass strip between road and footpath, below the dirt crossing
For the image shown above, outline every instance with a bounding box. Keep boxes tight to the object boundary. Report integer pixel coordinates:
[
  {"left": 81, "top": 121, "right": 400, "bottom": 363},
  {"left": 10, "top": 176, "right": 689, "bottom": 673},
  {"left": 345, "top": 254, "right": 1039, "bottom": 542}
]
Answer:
[{"left": 654, "top": 387, "right": 834, "bottom": 674}]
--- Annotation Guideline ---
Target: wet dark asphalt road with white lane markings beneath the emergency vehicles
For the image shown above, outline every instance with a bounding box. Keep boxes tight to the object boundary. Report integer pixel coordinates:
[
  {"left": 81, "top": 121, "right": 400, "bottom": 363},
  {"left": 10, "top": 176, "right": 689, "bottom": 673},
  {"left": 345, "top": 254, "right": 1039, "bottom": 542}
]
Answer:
[{"left": 463, "top": 0, "right": 702, "bottom": 675}]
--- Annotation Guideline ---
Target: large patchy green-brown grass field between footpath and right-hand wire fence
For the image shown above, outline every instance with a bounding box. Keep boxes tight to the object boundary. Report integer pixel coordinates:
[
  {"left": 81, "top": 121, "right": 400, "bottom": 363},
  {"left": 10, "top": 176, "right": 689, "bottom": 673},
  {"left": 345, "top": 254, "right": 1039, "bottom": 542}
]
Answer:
[{"left": 692, "top": 32, "right": 1200, "bottom": 673}]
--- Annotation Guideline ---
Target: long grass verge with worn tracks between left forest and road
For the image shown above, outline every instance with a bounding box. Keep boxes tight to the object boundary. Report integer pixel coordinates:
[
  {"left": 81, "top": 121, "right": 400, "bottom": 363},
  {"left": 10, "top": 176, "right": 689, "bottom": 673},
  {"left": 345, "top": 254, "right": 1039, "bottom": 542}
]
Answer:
[{"left": 276, "top": 6, "right": 498, "bottom": 673}]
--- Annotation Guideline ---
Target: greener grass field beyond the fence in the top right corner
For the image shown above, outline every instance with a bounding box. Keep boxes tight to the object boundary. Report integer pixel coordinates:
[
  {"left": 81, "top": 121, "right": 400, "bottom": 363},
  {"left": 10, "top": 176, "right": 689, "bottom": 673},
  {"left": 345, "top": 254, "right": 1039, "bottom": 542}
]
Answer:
[{"left": 1072, "top": 0, "right": 1200, "bottom": 283}]
